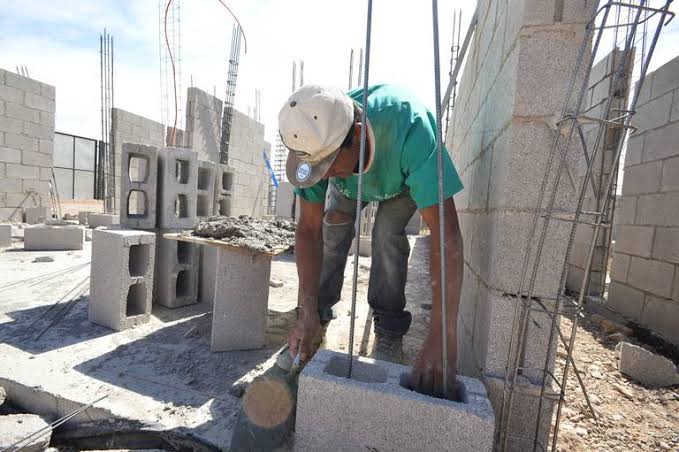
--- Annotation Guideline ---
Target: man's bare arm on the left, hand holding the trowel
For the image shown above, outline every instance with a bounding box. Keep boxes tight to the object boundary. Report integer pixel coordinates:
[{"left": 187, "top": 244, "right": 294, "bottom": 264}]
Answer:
[{"left": 288, "top": 198, "right": 325, "bottom": 361}]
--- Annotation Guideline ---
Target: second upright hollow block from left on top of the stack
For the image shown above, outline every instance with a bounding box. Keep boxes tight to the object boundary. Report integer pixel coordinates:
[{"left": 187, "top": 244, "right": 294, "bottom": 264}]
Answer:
[{"left": 156, "top": 147, "right": 198, "bottom": 229}]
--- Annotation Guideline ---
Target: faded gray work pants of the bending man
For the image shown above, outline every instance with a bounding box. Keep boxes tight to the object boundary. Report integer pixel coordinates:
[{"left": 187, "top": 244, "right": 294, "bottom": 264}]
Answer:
[{"left": 318, "top": 181, "right": 417, "bottom": 336}]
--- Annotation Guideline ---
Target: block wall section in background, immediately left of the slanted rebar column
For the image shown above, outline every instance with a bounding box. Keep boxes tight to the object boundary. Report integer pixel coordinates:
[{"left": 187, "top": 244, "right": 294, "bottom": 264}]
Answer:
[{"left": 186, "top": 87, "right": 223, "bottom": 162}]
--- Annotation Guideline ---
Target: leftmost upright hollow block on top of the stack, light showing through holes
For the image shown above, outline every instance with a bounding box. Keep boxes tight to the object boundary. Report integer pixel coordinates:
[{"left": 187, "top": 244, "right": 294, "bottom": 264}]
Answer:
[{"left": 120, "top": 143, "right": 158, "bottom": 229}]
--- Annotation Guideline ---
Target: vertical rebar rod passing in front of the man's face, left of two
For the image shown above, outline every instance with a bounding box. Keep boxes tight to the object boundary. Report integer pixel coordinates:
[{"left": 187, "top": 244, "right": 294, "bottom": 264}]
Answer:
[{"left": 347, "top": 0, "right": 373, "bottom": 378}]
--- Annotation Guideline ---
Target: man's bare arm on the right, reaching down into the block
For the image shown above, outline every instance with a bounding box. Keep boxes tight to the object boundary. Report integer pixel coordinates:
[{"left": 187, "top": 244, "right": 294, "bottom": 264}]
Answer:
[{"left": 410, "top": 198, "right": 464, "bottom": 399}]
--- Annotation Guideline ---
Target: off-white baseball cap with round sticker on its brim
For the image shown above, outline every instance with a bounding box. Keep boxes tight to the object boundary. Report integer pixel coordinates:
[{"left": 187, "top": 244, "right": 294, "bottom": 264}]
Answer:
[{"left": 278, "top": 85, "right": 354, "bottom": 188}]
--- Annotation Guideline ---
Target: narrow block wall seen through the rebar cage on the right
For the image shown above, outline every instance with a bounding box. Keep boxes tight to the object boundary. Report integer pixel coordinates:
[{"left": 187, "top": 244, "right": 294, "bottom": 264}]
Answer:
[{"left": 566, "top": 50, "right": 632, "bottom": 296}]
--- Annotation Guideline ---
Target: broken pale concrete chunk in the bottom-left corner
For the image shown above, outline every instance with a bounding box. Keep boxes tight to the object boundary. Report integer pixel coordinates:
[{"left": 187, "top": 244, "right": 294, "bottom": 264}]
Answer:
[{"left": 0, "top": 414, "right": 52, "bottom": 452}]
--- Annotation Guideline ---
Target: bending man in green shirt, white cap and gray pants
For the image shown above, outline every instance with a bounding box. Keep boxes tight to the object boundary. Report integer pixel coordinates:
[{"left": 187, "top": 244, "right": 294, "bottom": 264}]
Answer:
[{"left": 278, "top": 85, "right": 463, "bottom": 398}]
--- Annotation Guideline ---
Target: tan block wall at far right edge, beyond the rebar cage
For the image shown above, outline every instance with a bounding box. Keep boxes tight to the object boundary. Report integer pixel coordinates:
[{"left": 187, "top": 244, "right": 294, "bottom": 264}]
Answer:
[{"left": 608, "top": 57, "right": 679, "bottom": 345}]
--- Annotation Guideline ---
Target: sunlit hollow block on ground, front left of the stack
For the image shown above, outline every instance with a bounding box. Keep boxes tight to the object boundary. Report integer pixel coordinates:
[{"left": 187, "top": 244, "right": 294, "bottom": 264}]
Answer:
[{"left": 88, "top": 229, "right": 155, "bottom": 331}]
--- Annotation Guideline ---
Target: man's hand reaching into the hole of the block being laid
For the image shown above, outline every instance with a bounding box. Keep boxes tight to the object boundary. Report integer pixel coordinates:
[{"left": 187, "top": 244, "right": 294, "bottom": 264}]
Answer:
[{"left": 408, "top": 332, "right": 458, "bottom": 400}]
